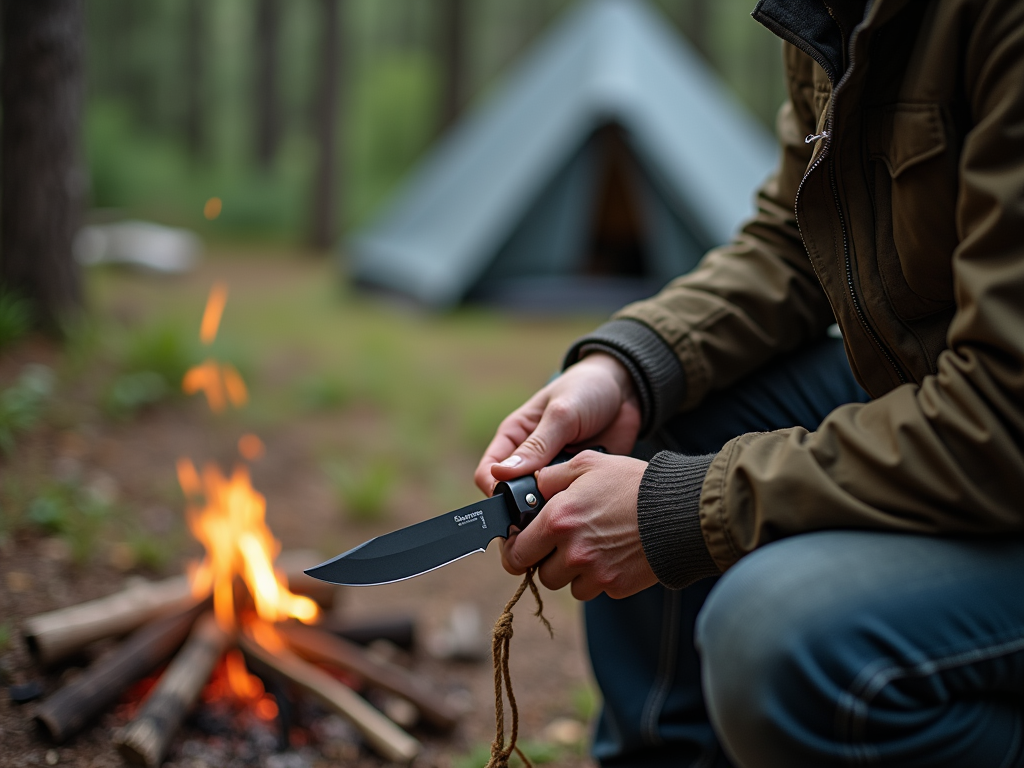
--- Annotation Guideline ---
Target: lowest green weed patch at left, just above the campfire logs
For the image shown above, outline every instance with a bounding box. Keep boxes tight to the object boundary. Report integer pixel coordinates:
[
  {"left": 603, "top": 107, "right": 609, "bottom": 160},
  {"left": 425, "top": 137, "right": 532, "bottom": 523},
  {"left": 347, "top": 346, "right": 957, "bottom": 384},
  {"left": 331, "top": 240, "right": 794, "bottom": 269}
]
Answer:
[{"left": 27, "top": 482, "right": 113, "bottom": 563}]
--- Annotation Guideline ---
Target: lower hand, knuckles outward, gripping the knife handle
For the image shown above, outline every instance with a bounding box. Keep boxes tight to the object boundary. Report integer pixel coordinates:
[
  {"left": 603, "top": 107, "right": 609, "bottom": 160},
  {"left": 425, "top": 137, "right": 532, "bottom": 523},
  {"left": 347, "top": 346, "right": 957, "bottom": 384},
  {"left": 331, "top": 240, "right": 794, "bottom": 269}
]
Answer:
[{"left": 502, "top": 451, "right": 657, "bottom": 600}]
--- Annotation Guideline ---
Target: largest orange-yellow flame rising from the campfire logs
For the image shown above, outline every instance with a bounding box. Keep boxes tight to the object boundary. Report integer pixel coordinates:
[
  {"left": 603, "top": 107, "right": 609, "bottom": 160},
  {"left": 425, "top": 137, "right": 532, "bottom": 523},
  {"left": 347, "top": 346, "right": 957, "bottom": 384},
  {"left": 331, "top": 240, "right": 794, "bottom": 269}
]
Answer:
[{"left": 178, "top": 459, "right": 319, "bottom": 630}]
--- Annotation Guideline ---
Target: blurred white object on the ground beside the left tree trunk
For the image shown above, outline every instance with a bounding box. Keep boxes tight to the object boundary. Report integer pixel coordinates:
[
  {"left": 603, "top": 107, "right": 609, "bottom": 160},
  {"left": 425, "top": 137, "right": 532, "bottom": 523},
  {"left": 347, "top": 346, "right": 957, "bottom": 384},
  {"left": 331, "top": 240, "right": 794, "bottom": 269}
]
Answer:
[{"left": 75, "top": 221, "right": 203, "bottom": 274}]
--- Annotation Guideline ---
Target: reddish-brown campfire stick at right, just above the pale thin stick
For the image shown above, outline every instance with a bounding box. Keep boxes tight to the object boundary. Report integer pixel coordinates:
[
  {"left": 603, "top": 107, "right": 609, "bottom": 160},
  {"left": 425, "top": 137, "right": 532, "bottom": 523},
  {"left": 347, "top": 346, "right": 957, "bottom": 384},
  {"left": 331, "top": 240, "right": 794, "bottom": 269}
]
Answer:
[{"left": 278, "top": 622, "right": 463, "bottom": 730}]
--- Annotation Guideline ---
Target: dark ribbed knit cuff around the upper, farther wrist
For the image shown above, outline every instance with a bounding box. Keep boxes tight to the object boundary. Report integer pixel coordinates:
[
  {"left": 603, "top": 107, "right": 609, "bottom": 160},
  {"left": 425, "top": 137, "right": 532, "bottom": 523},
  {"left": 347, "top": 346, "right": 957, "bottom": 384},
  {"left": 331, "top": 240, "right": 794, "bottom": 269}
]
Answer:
[{"left": 562, "top": 319, "right": 686, "bottom": 438}]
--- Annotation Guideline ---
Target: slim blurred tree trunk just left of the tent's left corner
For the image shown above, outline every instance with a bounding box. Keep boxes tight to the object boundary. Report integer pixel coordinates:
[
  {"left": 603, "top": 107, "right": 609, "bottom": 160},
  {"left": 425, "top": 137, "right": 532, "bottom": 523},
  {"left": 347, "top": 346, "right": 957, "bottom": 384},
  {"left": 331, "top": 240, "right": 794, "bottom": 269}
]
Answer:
[{"left": 311, "top": 0, "right": 344, "bottom": 248}]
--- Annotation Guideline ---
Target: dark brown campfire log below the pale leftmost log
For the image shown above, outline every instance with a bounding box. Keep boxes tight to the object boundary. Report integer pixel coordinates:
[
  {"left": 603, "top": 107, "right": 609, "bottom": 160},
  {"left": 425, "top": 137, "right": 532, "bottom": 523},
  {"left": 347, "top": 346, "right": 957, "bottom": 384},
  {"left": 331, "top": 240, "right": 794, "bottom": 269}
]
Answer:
[{"left": 36, "top": 601, "right": 206, "bottom": 742}]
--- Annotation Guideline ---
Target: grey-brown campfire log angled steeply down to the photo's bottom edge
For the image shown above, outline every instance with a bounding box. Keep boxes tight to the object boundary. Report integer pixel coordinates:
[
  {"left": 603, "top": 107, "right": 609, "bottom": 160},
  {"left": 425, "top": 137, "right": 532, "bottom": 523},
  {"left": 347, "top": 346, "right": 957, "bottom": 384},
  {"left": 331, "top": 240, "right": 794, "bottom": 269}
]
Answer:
[{"left": 114, "top": 612, "right": 231, "bottom": 768}]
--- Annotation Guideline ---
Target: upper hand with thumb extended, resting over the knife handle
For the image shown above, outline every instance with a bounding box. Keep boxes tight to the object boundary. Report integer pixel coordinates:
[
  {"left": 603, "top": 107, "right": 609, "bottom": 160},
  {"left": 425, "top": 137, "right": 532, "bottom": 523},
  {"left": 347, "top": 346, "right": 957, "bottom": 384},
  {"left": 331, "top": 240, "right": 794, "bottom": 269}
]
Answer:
[{"left": 474, "top": 352, "right": 641, "bottom": 496}]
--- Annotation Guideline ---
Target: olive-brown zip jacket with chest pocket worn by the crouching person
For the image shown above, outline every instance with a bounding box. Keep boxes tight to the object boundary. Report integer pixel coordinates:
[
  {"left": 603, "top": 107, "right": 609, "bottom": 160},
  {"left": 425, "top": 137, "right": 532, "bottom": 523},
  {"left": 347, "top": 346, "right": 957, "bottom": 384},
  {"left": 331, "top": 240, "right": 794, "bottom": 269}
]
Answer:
[{"left": 616, "top": 0, "right": 1024, "bottom": 570}]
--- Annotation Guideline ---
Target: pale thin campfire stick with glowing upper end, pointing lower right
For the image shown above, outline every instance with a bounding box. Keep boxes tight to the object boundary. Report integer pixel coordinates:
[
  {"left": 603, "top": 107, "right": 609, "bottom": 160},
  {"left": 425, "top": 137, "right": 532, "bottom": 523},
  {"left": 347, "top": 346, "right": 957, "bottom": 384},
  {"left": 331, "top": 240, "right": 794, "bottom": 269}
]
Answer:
[{"left": 239, "top": 622, "right": 420, "bottom": 763}]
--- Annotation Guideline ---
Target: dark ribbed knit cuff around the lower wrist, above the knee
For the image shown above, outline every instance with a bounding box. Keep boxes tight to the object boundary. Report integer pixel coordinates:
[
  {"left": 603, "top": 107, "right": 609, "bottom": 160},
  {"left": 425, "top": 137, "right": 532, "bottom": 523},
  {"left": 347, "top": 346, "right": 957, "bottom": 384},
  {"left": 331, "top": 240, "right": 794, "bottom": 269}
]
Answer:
[{"left": 637, "top": 451, "right": 721, "bottom": 589}]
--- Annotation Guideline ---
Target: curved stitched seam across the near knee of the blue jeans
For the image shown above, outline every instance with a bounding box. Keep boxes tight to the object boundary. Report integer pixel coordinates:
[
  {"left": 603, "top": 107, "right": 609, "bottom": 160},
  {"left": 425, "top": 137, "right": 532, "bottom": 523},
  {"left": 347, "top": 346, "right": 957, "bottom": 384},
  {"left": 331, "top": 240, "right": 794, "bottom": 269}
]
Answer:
[{"left": 836, "top": 636, "right": 1024, "bottom": 763}]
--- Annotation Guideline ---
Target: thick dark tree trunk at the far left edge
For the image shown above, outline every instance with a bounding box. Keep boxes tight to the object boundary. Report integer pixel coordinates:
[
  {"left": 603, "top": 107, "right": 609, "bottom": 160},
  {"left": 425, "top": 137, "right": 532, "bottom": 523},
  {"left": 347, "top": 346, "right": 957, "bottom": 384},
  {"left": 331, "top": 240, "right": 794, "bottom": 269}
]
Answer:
[{"left": 0, "top": 0, "right": 85, "bottom": 330}]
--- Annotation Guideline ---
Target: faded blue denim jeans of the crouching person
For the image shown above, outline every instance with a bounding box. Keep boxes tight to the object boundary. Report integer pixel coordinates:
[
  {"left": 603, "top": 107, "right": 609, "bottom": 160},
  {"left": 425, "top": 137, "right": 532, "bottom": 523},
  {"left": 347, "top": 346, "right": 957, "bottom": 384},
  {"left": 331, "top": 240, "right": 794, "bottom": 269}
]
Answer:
[{"left": 585, "top": 340, "right": 1024, "bottom": 768}]
